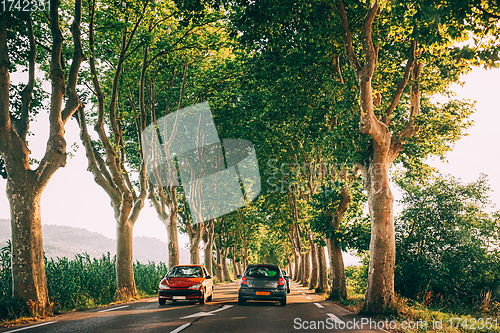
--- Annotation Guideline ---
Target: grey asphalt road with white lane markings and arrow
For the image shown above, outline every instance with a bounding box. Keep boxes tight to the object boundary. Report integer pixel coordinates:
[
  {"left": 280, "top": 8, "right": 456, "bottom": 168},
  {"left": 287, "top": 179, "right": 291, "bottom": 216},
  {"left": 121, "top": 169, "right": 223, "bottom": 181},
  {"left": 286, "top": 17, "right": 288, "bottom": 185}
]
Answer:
[{"left": 0, "top": 281, "right": 381, "bottom": 333}]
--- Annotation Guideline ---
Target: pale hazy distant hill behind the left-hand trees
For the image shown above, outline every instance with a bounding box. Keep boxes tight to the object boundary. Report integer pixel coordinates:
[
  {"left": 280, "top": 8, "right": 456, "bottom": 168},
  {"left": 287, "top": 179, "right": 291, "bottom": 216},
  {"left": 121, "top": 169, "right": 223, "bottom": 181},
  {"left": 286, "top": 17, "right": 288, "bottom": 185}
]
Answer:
[{"left": 0, "top": 219, "right": 189, "bottom": 264}]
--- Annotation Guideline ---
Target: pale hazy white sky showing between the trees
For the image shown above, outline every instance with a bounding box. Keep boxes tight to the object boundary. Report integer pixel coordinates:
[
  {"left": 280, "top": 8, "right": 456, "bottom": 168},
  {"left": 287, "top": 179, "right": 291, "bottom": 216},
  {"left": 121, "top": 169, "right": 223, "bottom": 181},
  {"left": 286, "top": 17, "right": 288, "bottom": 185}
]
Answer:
[{"left": 0, "top": 68, "right": 500, "bottom": 263}]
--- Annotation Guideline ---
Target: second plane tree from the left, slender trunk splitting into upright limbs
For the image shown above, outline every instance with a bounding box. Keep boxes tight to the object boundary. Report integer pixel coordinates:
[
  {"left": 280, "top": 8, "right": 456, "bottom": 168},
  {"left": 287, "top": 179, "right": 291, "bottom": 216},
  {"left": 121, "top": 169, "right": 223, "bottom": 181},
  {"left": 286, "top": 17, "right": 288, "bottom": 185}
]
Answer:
[{"left": 77, "top": 0, "right": 165, "bottom": 299}]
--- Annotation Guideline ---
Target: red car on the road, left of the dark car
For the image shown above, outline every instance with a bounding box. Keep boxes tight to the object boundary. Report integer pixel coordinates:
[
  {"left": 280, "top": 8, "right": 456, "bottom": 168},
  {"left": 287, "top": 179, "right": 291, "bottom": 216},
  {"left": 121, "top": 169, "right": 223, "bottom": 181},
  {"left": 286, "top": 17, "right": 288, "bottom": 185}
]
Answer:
[{"left": 158, "top": 265, "right": 214, "bottom": 305}]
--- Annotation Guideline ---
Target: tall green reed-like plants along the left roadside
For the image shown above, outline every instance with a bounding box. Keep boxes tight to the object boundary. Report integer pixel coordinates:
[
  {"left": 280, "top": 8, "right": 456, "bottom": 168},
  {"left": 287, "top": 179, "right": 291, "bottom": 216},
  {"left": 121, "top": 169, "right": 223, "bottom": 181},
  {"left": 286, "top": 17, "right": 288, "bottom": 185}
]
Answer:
[{"left": 0, "top": 242, "right": 167, "bottom": 325}]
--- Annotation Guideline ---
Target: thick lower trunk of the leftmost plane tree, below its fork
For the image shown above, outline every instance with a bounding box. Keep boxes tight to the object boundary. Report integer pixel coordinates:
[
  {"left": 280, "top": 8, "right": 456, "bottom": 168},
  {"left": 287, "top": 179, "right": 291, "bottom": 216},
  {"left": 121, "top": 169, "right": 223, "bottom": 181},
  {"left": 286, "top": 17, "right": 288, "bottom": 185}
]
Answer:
[{"left": 7, "top": 179, "right": 49, "bottom": 315}]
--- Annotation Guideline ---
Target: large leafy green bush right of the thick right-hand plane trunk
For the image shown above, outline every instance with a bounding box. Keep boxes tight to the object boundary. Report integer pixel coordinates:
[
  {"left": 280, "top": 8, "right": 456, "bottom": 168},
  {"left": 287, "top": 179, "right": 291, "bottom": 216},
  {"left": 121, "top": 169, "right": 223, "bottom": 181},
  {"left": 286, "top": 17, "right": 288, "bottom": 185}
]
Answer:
[{"left": 395, "top": 172, "right": 500, "bottom": 303}]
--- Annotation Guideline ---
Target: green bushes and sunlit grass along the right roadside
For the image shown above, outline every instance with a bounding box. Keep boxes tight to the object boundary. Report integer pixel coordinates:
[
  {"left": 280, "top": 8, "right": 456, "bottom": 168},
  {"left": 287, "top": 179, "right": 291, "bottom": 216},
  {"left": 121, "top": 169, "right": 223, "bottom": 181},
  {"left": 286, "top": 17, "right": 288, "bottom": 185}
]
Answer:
[{"left": 328, "top": 175, "right": 500, "bottom": 332}]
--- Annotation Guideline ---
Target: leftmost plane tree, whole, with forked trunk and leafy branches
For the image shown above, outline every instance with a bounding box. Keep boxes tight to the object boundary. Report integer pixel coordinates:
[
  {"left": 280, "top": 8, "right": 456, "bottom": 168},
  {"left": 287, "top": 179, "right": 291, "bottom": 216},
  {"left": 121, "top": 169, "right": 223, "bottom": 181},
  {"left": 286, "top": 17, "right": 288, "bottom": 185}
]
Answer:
[{"left": 0, "top": 0, "right": 85, "bottom": 314}]
